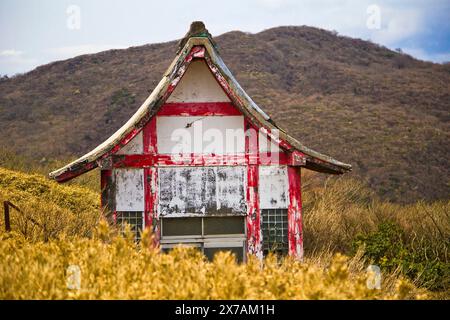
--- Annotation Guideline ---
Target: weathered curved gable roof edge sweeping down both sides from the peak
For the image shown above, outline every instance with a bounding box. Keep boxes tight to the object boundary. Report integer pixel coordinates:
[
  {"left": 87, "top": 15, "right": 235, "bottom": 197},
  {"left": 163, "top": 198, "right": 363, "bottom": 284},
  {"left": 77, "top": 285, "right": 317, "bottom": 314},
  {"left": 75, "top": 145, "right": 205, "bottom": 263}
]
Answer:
[{"left": 49, "top": 25, "right": 352, "bottom": 182}]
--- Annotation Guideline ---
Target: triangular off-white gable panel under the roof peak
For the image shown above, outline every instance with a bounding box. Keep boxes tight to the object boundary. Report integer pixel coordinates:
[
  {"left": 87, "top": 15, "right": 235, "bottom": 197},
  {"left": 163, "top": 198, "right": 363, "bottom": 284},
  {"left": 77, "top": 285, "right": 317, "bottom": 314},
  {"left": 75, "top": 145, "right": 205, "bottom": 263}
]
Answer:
[{"left": 167, "top": 60, "right": 230, "bottom": 102}]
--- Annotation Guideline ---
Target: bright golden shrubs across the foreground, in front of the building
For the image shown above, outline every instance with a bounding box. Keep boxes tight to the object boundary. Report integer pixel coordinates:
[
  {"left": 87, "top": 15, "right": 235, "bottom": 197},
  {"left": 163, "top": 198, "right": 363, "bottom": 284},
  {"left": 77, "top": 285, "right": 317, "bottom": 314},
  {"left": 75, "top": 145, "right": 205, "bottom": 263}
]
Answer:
[{"left": 0, "top": 223, "right": 427, "bottom": 299}]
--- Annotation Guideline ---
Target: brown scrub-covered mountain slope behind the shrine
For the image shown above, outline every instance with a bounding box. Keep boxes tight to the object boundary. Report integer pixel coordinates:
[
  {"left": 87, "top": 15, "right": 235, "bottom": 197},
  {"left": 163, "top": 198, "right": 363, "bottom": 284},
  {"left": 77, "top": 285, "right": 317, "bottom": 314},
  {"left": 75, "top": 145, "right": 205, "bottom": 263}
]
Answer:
[{"left": 0, "top": 27, "right": 450, "bottom": 202}]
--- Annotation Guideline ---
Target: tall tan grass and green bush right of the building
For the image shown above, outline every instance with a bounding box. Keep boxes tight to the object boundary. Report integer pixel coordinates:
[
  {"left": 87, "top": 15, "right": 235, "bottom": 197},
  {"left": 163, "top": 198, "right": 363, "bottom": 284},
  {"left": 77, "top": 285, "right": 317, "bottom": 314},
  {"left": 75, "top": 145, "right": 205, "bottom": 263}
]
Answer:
[{"left": 303, "top": 175, "right": 450, "bottom": 296}]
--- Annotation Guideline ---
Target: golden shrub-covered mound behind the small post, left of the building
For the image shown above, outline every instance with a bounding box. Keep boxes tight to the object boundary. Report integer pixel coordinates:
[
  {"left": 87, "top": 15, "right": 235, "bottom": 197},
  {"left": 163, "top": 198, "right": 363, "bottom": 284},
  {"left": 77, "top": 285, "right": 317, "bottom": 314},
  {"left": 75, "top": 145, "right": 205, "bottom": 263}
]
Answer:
[{"left": 0, "top": 168, "right": 101, "bottom": 241}]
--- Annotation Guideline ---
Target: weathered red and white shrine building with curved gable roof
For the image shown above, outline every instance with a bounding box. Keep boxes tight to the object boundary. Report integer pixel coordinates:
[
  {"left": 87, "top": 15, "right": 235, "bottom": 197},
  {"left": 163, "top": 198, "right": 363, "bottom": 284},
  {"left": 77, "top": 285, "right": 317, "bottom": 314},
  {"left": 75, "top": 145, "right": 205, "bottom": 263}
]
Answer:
[{"left": 50, "top": 22, "right": 351, "bottom": 260}]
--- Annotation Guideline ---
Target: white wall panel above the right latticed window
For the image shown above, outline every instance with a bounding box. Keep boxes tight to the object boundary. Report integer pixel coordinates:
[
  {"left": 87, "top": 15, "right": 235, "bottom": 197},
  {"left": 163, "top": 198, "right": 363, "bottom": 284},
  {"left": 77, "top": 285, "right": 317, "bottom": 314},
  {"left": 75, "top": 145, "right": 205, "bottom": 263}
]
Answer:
[{"left": 259, "top": 166, "right": 289, "bottom": 209}]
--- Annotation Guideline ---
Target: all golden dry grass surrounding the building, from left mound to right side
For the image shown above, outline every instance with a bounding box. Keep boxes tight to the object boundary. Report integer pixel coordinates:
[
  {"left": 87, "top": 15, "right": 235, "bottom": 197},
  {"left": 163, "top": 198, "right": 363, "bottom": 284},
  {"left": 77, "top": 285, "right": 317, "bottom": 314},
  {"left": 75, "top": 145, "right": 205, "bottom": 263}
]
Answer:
[{"left": 0, "top": 168, "right": 449, "bottom": 299}]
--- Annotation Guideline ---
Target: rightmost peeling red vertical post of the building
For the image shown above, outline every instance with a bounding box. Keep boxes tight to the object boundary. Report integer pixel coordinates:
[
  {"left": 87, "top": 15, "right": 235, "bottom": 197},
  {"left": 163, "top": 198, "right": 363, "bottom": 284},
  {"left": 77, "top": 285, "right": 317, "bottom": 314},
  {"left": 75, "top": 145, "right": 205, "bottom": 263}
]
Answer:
[{"left": 288, "top": 166, "right": 303, "bottom": 260}]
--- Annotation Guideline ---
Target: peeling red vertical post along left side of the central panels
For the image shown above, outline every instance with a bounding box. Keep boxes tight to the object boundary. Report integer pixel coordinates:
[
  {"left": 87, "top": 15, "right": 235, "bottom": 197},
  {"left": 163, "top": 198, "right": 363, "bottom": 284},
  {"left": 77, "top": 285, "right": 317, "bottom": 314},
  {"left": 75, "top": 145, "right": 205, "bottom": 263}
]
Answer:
[{"left": 143, "top": 117, "right": 161, "bottom": 246}]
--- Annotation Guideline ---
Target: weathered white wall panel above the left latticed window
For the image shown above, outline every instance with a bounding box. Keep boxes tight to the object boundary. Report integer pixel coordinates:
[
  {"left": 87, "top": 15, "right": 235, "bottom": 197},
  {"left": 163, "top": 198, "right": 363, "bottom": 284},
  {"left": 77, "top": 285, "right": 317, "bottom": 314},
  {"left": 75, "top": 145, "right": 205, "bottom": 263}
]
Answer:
[{"left": 114, "top": 169, "right": 144, "bottom": 211}]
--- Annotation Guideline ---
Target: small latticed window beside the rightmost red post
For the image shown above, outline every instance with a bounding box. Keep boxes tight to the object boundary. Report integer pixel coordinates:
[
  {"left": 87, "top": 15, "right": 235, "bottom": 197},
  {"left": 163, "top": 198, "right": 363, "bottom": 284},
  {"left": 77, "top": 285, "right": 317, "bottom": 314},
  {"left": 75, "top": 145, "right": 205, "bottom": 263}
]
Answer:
[{"left": 261, "top": 209, "right": 288, "bottom": 255}]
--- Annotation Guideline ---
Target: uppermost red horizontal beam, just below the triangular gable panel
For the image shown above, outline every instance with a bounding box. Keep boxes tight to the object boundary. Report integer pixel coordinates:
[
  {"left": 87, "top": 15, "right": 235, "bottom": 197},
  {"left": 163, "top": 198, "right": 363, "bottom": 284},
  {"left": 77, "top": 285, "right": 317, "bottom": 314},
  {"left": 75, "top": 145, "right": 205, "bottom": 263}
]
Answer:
[{"left": 157, "top": 102, "right": 242, "bottom": 116}]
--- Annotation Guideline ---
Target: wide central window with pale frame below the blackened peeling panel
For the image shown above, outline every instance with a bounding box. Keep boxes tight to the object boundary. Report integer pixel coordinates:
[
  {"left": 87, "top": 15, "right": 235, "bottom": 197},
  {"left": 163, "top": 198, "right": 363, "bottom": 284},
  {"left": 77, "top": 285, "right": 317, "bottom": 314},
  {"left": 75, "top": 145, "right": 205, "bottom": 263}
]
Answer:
[{"left": 161, "top": 216, "right": 245, "bottom": 262}]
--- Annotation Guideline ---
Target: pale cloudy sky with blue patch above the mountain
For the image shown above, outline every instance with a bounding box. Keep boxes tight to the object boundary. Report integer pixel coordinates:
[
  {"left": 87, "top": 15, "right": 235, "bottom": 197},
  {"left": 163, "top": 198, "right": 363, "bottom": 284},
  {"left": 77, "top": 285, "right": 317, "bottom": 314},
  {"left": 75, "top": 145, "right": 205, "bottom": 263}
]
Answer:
[{"left": 0, "top": 0, "right": 450, "bottom": 75}]
